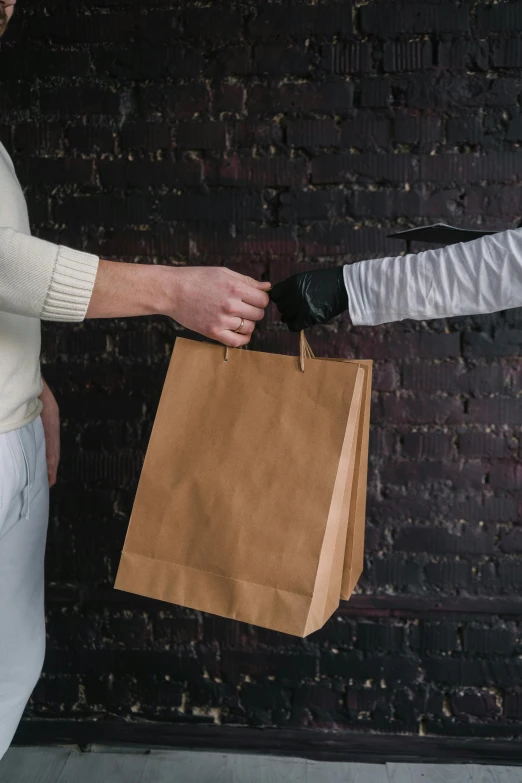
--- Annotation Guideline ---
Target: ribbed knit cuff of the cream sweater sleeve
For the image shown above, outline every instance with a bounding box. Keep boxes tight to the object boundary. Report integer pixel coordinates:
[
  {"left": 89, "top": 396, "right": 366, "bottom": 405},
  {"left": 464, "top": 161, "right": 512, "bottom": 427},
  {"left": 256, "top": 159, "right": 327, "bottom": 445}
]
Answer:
[{"left": 40, "top": 245, "right": 99, "bottom": 321}]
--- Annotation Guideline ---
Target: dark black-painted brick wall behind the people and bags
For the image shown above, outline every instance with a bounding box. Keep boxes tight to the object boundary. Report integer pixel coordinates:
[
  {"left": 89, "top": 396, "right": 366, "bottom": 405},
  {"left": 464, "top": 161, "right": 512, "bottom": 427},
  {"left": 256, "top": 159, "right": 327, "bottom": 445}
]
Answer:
[{"left": 0, "top": 0, "right": 522, "bottom": 737}]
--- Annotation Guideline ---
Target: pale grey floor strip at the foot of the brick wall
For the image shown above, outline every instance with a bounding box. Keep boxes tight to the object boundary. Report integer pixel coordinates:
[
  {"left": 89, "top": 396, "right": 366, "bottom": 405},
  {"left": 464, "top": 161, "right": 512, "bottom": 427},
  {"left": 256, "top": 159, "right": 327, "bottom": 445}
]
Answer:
[{"left": 0, "top": 746, "right": 522, "bottom": 783}]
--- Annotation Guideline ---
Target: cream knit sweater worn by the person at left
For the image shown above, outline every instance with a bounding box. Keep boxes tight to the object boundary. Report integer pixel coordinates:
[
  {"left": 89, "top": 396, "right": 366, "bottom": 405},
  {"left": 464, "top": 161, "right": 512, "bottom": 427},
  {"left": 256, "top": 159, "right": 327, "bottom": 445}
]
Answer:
[{"left": 0, "top": 143, "right": 98, "bottom": 432}]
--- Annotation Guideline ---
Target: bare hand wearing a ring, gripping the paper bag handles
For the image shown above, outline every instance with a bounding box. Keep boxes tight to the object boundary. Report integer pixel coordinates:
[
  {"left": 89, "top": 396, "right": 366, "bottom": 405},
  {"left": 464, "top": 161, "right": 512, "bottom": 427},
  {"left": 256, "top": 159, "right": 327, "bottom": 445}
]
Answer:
[{"left": 165, "top": 267, "right": 271, "bottom": 348}]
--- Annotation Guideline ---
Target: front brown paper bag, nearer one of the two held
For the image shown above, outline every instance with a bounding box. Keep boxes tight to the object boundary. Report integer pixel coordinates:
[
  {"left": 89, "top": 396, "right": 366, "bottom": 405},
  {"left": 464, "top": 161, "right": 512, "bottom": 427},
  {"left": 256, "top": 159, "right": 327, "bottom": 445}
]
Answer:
[{"left": 116, "top": 338, "right": 365, "bottom": 636}]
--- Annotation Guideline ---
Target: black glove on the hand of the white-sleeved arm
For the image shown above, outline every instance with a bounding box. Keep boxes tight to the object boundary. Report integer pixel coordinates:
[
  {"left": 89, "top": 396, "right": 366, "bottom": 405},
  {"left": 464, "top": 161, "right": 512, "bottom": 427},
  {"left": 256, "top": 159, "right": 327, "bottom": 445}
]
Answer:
[{"left": 269, "top": 266, "right": 348, "bottom": 332}]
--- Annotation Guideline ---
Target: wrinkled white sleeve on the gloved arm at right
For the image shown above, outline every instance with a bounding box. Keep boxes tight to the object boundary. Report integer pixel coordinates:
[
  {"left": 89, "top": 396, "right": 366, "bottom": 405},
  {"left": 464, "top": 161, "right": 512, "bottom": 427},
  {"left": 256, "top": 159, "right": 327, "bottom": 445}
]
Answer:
[{"left": 344, "top": 231, "right": 522, "bottom": 325}]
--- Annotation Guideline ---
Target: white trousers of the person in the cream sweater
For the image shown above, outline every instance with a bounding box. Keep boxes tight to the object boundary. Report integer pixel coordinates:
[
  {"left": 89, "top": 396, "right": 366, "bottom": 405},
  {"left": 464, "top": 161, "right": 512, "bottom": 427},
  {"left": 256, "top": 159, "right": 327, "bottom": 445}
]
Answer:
[{"left": 0, "top": 418, "right": 49, "bottom": 758}]
